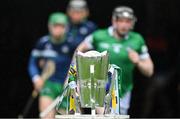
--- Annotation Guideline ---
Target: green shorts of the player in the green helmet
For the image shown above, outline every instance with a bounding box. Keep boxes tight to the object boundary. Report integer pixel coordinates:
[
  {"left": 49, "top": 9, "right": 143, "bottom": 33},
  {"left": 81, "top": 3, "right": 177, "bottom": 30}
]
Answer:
[{"left": 40, "top": 80, "right": 67, "bottom": 109}]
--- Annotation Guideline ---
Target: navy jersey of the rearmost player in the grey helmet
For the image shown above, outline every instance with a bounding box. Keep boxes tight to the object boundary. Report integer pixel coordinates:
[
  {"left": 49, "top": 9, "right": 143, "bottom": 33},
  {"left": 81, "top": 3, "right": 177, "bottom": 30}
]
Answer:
[{"left": 68, "top": 20, "right": 97, "bottom": 47}]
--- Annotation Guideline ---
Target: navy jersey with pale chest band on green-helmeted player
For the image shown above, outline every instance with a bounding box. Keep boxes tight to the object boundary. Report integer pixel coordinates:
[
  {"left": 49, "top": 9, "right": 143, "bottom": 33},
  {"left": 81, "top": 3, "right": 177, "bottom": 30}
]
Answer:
[{"left": 28, "top": 36, "right": 76, "bottom": 83}]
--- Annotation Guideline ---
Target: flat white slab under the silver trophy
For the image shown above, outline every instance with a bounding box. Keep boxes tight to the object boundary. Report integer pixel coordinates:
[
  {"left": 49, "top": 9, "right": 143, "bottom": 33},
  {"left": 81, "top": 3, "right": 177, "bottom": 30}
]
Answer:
[{"left": 55, "top": 115, "right": 130, "bottom": 119}]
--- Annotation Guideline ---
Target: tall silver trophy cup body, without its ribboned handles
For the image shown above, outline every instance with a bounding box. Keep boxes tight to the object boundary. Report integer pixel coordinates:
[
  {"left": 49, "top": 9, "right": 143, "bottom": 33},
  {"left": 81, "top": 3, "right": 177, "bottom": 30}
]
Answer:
[{"left": 76, "top": 51, "right": 109, "bottom": 109}]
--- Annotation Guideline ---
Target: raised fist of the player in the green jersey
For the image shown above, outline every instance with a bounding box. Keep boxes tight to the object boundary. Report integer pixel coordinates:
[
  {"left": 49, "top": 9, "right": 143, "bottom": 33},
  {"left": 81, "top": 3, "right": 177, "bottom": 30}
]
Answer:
[{"left": 128, "top": 49, "right": 140, "bottom": 64}]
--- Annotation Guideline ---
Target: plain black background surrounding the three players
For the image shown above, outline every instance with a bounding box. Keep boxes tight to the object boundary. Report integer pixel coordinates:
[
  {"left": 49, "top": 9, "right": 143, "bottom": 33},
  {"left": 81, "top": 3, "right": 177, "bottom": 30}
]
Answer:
[{"left": 0, "top": 0, "right": 180, "bottom": 117}]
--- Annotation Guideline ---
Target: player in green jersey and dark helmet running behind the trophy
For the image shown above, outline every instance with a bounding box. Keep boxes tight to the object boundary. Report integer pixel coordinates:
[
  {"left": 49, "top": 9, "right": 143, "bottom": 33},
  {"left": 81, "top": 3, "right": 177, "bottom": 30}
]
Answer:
[{"left": 74, "top": 6, "right": 154, "bottom": 114}]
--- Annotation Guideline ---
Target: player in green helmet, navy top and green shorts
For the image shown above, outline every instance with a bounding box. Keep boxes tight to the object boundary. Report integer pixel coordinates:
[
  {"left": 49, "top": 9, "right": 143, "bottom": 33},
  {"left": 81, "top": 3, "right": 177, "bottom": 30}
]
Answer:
[{"left": 29, "top": 12, "right": 76, "bottom": 118}]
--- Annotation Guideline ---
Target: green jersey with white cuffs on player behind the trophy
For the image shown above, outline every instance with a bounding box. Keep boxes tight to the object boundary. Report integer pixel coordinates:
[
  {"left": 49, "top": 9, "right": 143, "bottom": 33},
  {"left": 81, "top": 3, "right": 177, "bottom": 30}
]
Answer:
[{"left": 84, "top": 27, "right": 149, "bottom": 97}]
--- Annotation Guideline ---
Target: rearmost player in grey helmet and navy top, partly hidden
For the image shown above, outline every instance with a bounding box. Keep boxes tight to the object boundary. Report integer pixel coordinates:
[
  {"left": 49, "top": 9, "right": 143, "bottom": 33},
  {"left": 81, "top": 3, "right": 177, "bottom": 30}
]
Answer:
[{"left": 67, "top": 0, "right": 96, "bottom": 46}]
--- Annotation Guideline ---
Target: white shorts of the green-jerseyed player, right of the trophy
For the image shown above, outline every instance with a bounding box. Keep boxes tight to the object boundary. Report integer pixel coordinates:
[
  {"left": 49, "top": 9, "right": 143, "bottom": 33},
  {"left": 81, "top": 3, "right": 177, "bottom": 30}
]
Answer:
[{"left": 120, "top": 92, "right": 131, "bottom": 115}]
